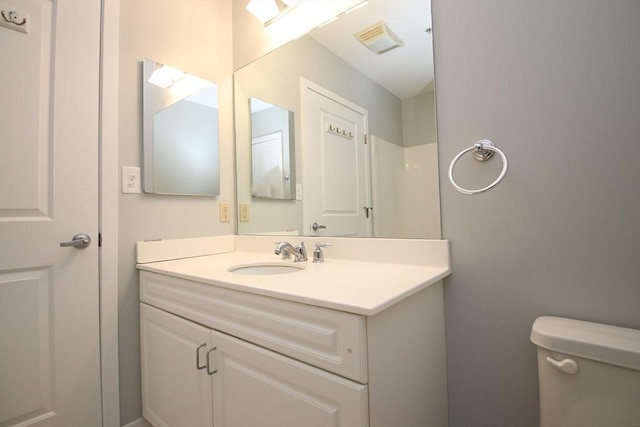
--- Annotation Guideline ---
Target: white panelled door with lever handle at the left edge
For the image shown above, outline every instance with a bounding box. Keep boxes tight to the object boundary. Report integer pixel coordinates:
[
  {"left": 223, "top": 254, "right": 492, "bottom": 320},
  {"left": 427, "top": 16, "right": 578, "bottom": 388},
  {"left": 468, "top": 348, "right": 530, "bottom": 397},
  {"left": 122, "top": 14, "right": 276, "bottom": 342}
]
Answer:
[{"left": 0, "top": 0, "right": 102, "bottom": 427}]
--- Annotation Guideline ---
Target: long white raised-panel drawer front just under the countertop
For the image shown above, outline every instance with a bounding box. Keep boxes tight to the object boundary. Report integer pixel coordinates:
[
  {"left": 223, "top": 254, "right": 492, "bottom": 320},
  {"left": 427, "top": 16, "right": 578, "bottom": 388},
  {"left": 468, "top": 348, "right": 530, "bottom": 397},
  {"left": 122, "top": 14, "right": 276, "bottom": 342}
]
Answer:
[{"left": 140, "top": 271, "right": 367, "bottom": 383}]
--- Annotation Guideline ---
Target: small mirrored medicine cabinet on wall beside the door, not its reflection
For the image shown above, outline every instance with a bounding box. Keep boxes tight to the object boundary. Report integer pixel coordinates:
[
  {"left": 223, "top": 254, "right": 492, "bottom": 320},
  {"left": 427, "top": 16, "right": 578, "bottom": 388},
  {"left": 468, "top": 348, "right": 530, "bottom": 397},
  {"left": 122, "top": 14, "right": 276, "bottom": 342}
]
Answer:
[{"left": 142, "top": 59, "right": 220, "bottom": 196}]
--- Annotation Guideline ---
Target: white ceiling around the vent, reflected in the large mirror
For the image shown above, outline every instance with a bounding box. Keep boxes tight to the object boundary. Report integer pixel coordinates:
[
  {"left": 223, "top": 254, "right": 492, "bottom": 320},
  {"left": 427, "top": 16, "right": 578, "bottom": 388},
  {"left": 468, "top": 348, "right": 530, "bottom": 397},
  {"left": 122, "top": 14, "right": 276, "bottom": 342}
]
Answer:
[{"left": 309, "top": 0, "right": 433, "bottom": 99}]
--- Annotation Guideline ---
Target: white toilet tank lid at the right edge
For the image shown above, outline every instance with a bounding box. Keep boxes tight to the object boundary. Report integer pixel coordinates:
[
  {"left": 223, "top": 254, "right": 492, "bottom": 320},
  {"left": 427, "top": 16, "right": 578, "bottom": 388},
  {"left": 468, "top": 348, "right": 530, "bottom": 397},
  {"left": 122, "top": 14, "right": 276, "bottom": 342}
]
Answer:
[{"left": 531, "top": 316, "right": 640, "bottom": 371}]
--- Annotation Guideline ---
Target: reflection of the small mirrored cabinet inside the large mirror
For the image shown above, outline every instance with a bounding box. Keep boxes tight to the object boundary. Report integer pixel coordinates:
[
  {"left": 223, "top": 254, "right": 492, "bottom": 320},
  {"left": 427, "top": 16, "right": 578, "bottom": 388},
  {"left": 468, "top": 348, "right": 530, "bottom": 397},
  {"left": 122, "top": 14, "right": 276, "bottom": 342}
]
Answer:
[{"left": 249, "top": 98, "right": 295, "bottom": 200}]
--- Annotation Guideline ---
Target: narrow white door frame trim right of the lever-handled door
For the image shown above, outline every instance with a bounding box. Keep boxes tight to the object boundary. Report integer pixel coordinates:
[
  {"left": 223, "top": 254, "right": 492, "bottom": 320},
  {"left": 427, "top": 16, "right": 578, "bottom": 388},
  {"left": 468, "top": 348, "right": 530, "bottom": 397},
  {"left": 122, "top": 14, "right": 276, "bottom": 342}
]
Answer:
[{"left": 98, "top": 0, "right": 121, "bottom": 427}]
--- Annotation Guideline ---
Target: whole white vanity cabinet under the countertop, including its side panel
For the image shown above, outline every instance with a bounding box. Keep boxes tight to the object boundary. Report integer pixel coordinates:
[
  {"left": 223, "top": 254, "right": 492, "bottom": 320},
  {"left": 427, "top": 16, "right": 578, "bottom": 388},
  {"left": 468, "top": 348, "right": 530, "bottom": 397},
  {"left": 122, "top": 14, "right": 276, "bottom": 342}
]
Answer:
[{"left": 140, "top": 271, "right": 447, "bottom": 427}]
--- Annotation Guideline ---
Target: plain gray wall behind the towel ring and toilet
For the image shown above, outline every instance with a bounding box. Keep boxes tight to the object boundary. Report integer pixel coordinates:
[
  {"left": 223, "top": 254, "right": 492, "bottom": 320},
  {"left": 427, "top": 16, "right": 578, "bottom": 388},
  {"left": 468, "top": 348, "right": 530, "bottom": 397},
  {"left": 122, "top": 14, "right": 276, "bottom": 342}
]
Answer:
[{"left": 433, "top": 0, "right": 640, "bottom": 427}]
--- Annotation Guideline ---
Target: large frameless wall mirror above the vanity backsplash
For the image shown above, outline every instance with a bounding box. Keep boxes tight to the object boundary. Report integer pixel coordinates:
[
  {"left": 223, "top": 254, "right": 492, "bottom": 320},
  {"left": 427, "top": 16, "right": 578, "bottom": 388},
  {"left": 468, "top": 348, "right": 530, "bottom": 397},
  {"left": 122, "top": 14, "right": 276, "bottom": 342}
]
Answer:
[{"left": 234, "top": 0, "right": 441, "bottom": 238}]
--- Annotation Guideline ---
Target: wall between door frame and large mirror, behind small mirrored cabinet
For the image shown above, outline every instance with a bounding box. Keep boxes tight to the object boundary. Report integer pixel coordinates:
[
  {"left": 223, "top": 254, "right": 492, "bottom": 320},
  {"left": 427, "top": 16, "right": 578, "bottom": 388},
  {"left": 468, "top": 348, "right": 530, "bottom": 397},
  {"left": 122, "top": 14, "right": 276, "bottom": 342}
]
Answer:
[{"left": 118, "top": 0, "right": 235, "bottom": 425}]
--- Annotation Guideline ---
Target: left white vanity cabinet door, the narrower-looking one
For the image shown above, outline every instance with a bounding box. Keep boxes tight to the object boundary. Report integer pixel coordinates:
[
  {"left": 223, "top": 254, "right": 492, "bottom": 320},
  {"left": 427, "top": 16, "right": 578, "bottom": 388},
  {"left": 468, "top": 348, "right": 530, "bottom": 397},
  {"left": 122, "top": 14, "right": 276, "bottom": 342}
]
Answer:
[{"left": 140, "top": 304, "right": 213, "bottom": 427}]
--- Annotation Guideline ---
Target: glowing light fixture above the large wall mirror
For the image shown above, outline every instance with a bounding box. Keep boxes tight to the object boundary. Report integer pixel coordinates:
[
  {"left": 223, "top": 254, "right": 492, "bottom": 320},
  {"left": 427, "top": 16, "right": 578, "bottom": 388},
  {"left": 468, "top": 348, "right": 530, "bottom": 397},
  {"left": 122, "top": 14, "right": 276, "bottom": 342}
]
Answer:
[{"left": 247, "top": 0, "right": 367, "bottom": 38}]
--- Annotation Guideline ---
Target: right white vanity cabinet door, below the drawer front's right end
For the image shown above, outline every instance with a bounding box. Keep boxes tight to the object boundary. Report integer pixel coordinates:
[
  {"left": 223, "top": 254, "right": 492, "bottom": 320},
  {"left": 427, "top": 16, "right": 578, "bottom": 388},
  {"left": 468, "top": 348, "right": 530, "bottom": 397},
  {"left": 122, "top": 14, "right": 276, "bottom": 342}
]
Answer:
[{"left": 211, "top": 331, "right": 368, "bottom": 427}]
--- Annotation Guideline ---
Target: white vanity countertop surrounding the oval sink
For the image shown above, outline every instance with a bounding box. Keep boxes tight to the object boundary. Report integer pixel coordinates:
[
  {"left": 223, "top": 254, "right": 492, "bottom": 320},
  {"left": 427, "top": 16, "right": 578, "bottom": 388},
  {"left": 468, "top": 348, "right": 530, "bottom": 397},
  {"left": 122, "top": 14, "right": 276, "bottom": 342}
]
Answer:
[{"left": 138, "top": 239, "right": 450, "bottom": 315}]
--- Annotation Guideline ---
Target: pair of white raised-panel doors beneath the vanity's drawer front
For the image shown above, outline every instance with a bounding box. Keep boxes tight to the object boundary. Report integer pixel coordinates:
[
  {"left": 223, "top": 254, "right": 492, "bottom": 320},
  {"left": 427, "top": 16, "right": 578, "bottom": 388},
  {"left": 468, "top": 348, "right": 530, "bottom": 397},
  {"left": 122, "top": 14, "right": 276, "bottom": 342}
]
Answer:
[{"left": 140, "top": 303, "right": 368, "bottom": 427}]
